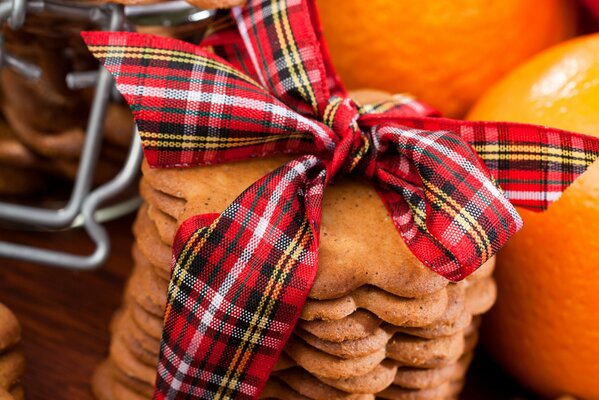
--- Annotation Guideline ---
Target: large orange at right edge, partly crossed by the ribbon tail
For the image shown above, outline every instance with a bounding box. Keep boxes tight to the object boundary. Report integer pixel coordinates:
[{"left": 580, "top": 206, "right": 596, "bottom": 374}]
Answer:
[{"left": 468, "top": 34, "right": 599, "bottom": 399}]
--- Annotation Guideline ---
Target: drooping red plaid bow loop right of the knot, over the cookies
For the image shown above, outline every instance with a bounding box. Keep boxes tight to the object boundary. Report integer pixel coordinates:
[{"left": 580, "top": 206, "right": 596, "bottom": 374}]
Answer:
[{"left": 375, "top": 123, "right": 522, "bottom": 280}]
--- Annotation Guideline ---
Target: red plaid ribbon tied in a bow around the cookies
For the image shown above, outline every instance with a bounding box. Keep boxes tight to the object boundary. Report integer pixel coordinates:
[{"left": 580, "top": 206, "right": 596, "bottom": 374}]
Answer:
[{"left": 84, "top": 0, "right": 599, "bottom": 399}]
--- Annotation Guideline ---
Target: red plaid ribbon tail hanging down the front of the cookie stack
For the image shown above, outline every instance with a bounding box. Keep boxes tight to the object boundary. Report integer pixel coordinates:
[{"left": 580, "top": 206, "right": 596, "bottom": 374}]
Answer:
[{"left": 154, "top": 156, "right": 326, "bottom": 399}]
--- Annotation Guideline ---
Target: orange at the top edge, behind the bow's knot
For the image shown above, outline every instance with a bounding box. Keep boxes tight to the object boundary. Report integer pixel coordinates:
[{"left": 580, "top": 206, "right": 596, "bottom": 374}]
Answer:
[{"left": 317, "top": 0, "right": 577, "bottom": 117}]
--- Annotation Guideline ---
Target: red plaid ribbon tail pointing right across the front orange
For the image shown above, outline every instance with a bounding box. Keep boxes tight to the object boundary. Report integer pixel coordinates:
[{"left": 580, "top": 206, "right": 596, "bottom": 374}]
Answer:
[{"left": 395, "top": 118, "right": 599, "bottom": 211}]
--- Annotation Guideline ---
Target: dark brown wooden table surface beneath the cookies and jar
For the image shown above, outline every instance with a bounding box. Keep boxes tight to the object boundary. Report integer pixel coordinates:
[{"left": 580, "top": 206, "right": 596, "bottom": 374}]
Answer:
[{"left": 0, "top": 211, "right": 534, "bottom": 400}]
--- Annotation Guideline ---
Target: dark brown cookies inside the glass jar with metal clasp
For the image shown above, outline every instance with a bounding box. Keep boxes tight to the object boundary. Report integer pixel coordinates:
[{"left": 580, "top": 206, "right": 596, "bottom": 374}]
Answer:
[{"left": 0, "top": 17, "right": 133, "bottom": 194}]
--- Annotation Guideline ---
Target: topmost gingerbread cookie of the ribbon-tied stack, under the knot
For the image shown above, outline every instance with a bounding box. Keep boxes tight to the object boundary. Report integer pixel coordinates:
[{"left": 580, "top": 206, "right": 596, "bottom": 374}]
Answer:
[{"left": 142, "top": 157, "right": 448, "bottom": 300}]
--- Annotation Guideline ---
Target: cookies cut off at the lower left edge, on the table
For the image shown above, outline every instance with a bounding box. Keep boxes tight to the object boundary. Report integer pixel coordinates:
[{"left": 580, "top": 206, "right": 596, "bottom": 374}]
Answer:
[{"left": 0, "top": 303, "right": 25, "bottom": 400}]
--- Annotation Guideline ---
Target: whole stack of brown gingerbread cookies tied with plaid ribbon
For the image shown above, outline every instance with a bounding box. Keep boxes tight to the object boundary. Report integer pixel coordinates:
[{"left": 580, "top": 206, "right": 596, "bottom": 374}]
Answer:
[{"left": 94, "top": 135, "right": 495, "bottom": 400}]
